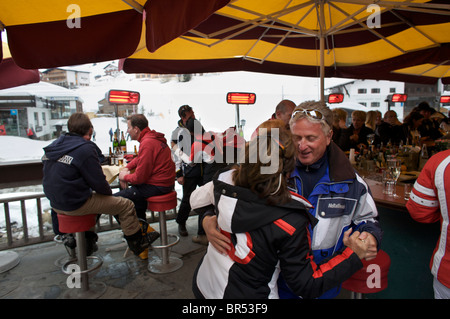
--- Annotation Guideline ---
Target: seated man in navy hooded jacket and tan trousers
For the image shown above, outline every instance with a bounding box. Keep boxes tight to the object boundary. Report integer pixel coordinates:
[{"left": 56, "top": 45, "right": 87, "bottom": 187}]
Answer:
[{"left": 42, "top": 113, "right": 149, "bottom": 255}]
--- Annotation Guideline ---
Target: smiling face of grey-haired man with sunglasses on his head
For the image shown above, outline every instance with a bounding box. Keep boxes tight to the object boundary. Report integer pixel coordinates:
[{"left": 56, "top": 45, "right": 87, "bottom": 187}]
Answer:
[{"left": 291, "top": 118, "right": 333, "bottom": 165}]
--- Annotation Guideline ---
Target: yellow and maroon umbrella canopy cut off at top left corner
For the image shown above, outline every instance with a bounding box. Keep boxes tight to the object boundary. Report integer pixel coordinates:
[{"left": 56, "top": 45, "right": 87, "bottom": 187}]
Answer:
[{"left": 0, "top": 0, "right": 228, "bottom": 69}]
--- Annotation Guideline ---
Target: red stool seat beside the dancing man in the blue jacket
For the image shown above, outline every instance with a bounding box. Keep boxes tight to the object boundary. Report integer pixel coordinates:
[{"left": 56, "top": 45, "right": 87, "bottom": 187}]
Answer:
[{"left": 342, "top": 250, "right": 391, "bottom": 299}]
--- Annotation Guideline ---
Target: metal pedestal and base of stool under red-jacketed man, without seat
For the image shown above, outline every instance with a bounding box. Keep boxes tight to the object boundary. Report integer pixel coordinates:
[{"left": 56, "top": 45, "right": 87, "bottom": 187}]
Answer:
[{"left": 148, "top": 211, "right": 183, "bottom": 274}]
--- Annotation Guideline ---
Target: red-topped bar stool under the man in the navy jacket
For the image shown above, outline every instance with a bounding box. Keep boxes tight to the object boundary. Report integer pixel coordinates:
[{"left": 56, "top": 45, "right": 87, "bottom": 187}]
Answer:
[{"left": 58, "top": 214, "right": 106, "bottom": 298}]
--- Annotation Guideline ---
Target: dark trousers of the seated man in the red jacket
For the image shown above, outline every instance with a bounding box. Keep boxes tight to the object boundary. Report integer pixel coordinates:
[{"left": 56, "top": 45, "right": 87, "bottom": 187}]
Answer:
[{"left": 114, "top": 184, "right": 174, "bottom": 220}]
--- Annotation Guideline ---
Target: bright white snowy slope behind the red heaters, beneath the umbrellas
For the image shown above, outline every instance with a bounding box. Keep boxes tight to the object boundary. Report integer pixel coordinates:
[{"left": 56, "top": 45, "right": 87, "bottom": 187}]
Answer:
[{"left": 75, "top": 72, "right": 328, "bottom": 142}]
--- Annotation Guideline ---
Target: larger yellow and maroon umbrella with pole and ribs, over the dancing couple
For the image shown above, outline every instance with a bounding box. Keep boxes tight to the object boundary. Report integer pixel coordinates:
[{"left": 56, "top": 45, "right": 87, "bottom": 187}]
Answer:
[{"left": 121, "top": 0, "right": 450, "bottom": 98}]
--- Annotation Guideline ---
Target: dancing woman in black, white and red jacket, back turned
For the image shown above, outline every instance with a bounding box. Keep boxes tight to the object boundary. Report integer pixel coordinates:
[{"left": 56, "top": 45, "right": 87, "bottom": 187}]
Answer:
[{"left": 190, "top": 121, "right": 369, "bottom": 299}]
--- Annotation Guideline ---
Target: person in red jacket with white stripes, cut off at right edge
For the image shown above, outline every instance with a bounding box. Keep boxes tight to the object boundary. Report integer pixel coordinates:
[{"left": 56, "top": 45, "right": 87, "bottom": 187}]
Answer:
[{"left": 406, "top": 150, "right": 450, "bottom": 299}]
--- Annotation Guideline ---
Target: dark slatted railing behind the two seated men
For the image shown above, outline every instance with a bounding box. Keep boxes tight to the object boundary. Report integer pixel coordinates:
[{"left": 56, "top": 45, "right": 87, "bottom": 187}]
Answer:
[{"left": 0, "top": 191, "right": 179, "bottom": 251}]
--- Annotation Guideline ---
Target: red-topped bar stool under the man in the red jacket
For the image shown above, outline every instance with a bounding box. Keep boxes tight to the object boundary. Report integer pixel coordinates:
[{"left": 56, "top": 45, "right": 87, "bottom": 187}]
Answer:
[{"left": 147, "top": 191, "right": 183, "bottom": 274}]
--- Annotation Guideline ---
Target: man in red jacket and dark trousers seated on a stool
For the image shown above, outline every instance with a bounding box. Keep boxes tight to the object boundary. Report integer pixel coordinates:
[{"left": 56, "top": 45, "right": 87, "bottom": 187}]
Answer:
[{"left": 114, "top": 114, "right": 175, "bottom": 251}]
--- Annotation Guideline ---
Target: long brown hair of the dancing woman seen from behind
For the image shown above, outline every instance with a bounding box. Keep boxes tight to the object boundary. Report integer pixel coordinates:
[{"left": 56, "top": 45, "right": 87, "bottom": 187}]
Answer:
[{"left": 233, "top": 120, "right": 295, "bottom": 205}]
